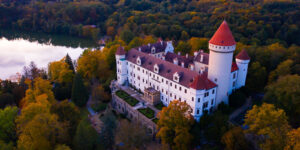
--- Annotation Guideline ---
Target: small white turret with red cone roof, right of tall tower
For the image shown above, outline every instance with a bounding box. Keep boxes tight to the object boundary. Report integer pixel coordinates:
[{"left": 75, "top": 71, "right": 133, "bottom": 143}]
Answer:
[{"left": 235, "top": 49, "right": 250, "bottom": 88}]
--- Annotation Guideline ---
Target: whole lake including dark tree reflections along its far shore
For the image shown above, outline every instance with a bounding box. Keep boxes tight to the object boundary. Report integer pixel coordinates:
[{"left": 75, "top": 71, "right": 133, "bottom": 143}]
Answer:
[{"left": 0, "top": 30, "right": 97, "bottom": 80}]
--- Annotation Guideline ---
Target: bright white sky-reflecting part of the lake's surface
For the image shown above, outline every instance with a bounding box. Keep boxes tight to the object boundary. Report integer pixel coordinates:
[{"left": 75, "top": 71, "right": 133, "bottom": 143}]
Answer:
[{"left": 0, "top": 38, "right": 84, "bottom": 80}]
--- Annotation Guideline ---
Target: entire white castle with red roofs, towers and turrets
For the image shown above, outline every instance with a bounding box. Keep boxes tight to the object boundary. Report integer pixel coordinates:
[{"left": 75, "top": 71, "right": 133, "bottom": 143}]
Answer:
[{"left": 115, "top": 21, "right": 250, "bottom": 120}]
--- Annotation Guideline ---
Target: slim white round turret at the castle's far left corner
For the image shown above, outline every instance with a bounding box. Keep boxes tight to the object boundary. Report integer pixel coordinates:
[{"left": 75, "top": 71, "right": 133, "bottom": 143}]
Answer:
[{"left": 116, "top": 46, "right": 128, "bottom": 85}]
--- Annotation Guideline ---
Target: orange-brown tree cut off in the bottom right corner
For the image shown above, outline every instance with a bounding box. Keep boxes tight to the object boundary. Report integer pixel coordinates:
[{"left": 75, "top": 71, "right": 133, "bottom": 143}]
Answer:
[{"left": 284, "top": 128, "right": 300, "bottom": 150}]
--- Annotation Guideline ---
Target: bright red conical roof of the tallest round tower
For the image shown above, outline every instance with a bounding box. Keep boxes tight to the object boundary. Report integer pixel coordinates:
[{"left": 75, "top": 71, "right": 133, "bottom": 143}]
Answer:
[{"left": 209, "top": 21, "right": 236, "bottom": 46}]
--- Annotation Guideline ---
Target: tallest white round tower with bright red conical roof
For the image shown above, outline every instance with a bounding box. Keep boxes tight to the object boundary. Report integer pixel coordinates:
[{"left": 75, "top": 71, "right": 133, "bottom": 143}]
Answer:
[{"left": 208, "top": 21, "right": 236, "bottom": 106}]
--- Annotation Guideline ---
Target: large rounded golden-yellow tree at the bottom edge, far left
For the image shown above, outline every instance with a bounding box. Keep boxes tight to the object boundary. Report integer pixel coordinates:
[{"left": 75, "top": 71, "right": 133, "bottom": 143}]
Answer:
[{"left": 18, "top": 113, "right": 66, "bottom": 150}]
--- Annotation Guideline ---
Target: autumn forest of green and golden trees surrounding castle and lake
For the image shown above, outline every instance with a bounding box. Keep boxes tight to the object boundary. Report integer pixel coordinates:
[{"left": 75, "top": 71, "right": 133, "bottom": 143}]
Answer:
[{"left": 0, "top": 0, "right": 300, "bottom": 150}]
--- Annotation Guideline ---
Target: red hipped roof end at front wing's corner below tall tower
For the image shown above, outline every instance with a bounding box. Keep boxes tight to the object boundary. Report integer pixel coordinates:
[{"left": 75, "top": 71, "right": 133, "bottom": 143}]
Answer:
[{"left": 190, "top": 75, "right": 217, "bottom": 90}]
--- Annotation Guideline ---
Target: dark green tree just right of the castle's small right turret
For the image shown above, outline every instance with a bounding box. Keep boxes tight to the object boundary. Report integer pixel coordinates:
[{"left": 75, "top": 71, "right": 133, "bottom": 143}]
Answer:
[{"left": 246, "top": 62, "right": 267, "bottom": 92}]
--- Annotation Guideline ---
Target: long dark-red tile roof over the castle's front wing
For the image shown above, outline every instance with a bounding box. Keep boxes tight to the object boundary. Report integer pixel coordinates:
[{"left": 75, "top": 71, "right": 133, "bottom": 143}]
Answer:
[{"left": 126, "top": 48, "right": 216, "bottom": 87}]
